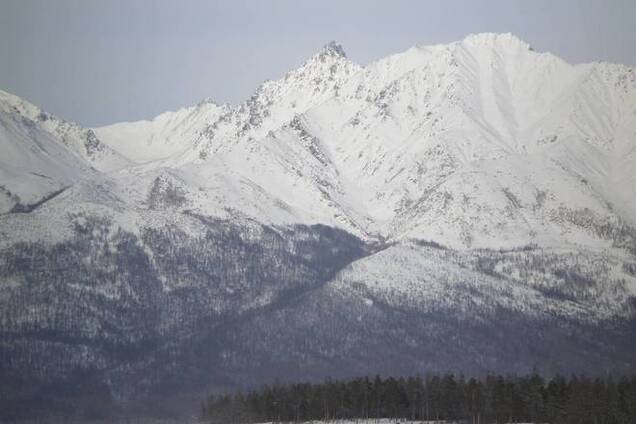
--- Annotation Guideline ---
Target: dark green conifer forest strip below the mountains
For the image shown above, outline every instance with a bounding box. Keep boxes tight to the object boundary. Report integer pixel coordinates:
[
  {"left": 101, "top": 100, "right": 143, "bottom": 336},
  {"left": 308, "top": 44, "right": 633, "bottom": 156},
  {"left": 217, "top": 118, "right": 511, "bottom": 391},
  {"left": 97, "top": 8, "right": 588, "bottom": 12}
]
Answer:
[{"left": 202, "top": 374, "right": 636, "bottom": 424}]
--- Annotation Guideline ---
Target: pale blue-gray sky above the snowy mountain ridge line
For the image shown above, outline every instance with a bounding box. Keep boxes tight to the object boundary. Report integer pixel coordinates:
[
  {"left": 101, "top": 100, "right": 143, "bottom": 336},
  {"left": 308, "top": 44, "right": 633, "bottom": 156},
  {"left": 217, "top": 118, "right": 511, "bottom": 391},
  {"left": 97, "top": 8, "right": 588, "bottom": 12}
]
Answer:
[{"left": 0, "top": 0, "right": 636, "bottom": 126}]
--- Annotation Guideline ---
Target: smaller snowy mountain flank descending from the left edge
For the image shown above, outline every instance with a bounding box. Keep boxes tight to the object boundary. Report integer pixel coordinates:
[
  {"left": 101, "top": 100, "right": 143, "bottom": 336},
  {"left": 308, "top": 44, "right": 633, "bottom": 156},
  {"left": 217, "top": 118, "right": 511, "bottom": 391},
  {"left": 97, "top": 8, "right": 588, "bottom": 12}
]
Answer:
[{"left": 0, "top": 91, "right": 130, "bottom": 213}]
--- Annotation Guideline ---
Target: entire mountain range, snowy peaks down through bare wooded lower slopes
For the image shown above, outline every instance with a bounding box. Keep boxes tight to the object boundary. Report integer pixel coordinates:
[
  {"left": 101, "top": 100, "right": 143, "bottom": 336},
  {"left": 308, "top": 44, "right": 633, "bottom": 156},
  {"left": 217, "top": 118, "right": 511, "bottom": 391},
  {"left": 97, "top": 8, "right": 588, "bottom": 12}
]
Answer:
[{"left": 0, "top": 34, "right": 636, "bottom": 418}]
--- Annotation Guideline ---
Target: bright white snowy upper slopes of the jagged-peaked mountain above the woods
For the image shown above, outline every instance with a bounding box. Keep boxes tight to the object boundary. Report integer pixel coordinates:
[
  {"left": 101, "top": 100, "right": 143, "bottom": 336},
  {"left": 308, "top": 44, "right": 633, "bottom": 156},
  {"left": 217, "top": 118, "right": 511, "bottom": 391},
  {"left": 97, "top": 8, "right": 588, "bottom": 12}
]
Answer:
[{"left": 88, "top": 34, "right": 636, "bottom": 248}]
